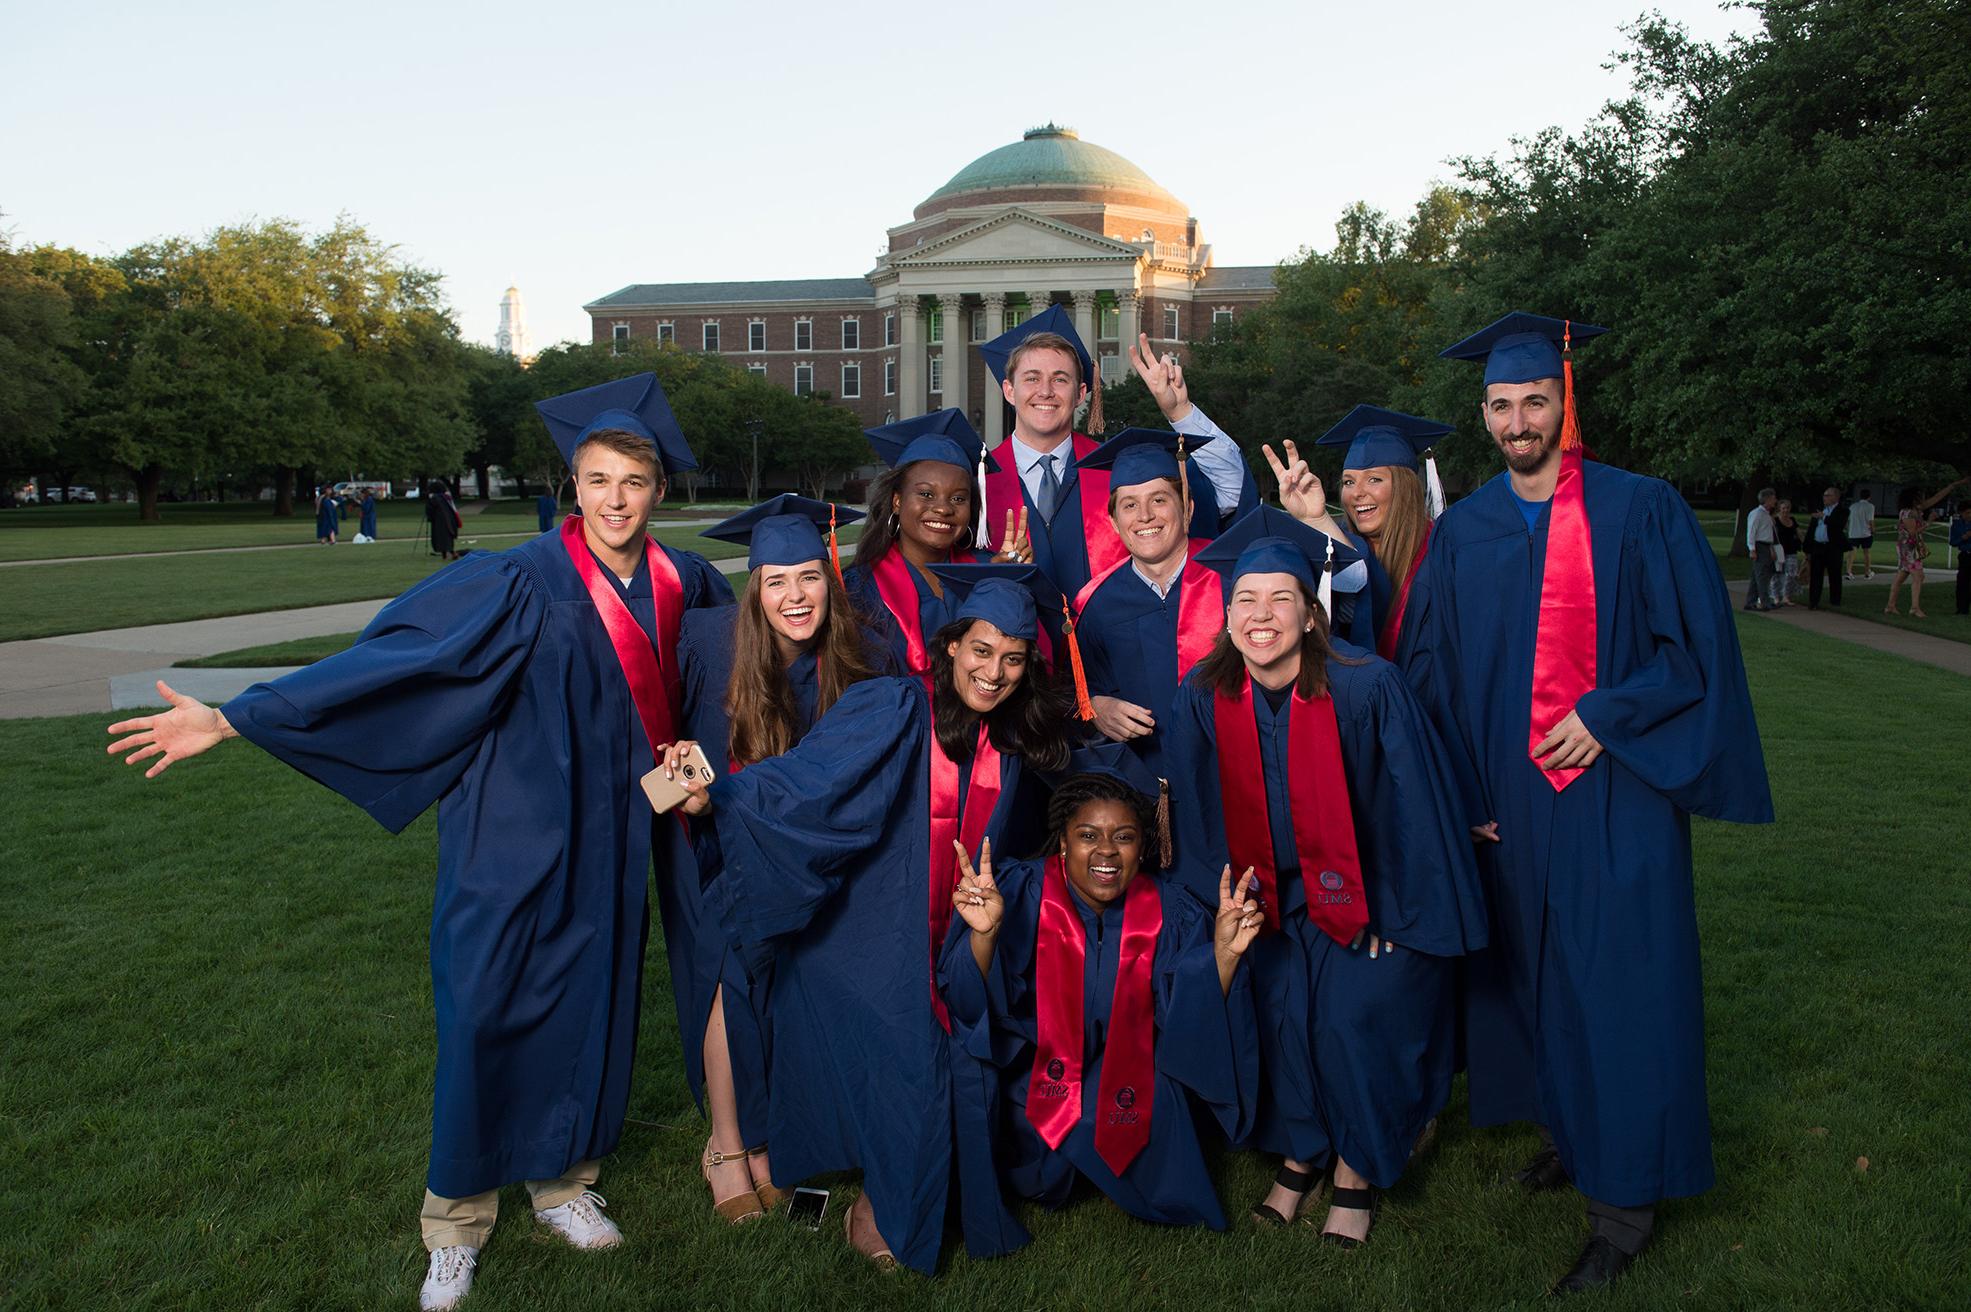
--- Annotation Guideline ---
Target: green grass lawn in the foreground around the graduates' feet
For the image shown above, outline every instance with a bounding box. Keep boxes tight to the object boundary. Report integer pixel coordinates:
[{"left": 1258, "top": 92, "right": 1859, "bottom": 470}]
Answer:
[{"left": 0, "top": 623, "right": 1971, "bottom": 1312}]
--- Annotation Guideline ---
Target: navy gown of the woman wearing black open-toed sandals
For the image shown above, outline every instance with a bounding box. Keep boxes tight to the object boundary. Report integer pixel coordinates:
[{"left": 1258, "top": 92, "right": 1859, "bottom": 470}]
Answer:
[{"left": 1169, "top": 642, "right": 1484, "bottom": 1188}]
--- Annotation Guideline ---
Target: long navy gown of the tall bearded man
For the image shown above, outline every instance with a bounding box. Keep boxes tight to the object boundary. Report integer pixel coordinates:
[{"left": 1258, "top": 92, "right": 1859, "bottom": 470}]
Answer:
[{"left": 1399, "top": 461, "right": 1772, "bottom": 1206}]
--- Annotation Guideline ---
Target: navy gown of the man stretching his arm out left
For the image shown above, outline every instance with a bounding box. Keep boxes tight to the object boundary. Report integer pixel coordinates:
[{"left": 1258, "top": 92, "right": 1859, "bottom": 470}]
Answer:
[{"left": 223, "top": 536, "right": 731, "bottom": 1198}]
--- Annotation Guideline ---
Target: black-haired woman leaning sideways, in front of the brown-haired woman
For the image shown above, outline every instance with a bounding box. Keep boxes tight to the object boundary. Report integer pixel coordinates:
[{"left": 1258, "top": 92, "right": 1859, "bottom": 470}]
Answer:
[{"left": 686, "top": 565, "right": 1068, "bottom": 1273}]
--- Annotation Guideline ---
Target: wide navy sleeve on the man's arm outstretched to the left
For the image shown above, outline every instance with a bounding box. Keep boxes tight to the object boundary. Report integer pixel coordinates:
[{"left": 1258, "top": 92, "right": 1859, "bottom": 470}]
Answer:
[{"left": 221, "top": 554, "right": 548, "bottom": 833}]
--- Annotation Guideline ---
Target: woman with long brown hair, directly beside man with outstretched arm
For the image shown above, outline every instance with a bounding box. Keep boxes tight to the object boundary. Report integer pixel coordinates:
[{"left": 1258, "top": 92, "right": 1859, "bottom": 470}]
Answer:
[{"left": 678, "top": 496, "right": 887, "bottom": 1221}]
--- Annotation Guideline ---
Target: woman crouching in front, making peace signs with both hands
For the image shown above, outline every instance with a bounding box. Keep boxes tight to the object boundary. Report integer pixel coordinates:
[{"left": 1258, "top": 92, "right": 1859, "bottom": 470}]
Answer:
[{"left": 942, "top": 745, "right": 1261, "bottom": 1229}]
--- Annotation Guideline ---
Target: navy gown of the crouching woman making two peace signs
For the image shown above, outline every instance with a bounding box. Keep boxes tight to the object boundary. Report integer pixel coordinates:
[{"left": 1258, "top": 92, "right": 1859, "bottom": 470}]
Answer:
[{"left": 940, "top": 861, "right": 1259, "bottom": 1229}]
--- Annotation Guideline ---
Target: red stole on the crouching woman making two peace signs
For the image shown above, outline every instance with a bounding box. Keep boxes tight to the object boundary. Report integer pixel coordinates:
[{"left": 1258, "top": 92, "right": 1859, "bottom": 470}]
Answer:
[{"left": 1027, "top": 855, "right": 1163, "bottom": 1176}]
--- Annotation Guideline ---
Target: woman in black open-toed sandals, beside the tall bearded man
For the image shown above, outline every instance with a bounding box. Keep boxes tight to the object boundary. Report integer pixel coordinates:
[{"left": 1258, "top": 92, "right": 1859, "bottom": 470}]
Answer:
[{"left": 1169, "top": 508, "right": 1486, "bottom": 1245}]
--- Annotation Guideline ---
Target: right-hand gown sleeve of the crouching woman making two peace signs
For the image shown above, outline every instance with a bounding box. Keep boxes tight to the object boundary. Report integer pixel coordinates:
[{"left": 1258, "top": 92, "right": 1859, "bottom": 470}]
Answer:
[{"left": 1157, "top": 886, "right": 1259, "bottom": 1143}]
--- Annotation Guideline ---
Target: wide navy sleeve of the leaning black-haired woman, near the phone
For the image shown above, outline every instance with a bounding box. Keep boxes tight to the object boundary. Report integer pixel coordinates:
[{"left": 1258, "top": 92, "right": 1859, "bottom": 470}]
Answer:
[{"left": 706, "top": 680, "right": 930, "bottom": 948}]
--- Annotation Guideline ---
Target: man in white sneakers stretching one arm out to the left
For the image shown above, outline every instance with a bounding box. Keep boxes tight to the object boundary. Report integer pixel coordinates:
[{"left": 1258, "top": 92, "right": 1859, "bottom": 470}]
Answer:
[{"left": 110, "top": 374, "right": 731, "bottom": 1308}]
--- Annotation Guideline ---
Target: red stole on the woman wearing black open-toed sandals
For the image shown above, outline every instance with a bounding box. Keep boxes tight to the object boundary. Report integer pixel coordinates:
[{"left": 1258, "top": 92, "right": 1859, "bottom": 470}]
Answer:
[{"left": 1212, "top": 674, "right": 1368, "bottom": 948}]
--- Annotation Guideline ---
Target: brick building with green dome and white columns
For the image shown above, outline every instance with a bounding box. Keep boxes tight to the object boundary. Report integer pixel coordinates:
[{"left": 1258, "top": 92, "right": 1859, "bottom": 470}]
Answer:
[{"left": 583, "top": 124, "right": 1273, "bottom": 445}]
